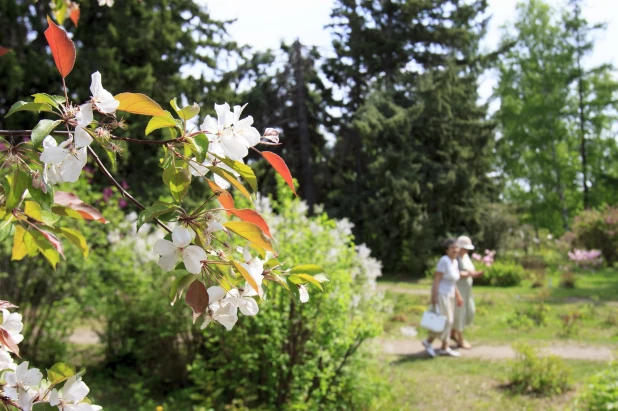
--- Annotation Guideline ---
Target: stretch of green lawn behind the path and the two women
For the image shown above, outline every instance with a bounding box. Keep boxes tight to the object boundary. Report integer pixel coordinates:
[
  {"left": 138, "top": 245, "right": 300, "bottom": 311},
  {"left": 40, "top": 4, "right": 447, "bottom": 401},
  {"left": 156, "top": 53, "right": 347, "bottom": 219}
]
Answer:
[{"left": 380, "top": 270, "right": 618, "bottom": 346}]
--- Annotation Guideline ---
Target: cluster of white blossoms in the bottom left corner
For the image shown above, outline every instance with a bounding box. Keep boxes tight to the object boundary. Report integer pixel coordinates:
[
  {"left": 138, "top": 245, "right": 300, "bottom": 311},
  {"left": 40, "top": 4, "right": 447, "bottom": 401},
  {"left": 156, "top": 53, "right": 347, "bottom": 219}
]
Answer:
[{"left": 0, "top": 300, "right": 101, "bottom": 411}]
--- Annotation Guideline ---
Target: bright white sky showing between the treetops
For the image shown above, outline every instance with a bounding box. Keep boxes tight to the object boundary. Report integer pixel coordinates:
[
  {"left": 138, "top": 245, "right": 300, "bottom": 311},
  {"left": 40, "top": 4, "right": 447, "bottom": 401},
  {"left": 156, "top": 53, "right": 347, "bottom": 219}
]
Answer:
[{"left": 202, "top": 0, "right": 618, "bottom": 104}]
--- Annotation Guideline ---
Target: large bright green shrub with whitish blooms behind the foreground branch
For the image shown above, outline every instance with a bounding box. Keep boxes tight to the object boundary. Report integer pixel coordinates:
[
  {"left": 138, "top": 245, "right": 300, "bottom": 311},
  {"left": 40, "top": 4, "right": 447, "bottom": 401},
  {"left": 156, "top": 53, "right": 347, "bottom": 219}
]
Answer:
[{"left": 190, "top": 183, "right": 387, "bottom": 410}]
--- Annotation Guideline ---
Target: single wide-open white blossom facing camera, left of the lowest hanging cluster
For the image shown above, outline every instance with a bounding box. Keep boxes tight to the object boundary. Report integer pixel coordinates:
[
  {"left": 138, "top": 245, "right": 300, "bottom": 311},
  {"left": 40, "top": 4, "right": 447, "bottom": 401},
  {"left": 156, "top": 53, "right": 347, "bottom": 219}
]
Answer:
[{"left": 153, "top": 226, "right": 207, "bottom": 274}]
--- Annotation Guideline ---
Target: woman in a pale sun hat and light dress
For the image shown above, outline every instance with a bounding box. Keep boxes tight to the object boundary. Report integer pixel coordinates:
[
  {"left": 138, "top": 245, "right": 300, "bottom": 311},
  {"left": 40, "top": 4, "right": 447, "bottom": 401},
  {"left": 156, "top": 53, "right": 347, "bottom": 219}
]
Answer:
[{"left": 452, "top": 235, "right": 483, "bottom": 349}]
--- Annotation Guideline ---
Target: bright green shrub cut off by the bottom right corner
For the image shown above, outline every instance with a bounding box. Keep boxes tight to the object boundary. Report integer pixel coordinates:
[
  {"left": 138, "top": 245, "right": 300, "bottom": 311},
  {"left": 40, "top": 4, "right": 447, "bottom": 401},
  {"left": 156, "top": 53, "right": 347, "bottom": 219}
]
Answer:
[{"left": 576, "top": 363, "right": 618, "bottom": 411}]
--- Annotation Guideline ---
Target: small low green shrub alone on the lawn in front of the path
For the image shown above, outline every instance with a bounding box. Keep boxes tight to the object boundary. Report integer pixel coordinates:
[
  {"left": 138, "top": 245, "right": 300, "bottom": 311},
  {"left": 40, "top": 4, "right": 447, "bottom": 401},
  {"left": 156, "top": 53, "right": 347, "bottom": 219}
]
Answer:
[{"left": 509, "top": 344, "right": 571, "bottom": 395}]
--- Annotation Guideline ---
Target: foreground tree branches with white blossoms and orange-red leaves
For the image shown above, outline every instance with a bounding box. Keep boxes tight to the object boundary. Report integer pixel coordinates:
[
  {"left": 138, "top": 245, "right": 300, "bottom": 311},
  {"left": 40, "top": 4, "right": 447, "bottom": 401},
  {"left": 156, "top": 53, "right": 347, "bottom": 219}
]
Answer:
[{"left": 0, "top": 12, "right": 328, "bottom": 410}]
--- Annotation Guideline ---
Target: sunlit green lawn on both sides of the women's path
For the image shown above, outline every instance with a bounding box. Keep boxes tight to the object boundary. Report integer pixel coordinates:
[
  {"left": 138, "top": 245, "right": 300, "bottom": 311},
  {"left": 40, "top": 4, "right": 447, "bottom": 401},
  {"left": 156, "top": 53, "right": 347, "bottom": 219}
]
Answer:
[{"left": 380, "top": 269, "right": 618, "bottom": 410}]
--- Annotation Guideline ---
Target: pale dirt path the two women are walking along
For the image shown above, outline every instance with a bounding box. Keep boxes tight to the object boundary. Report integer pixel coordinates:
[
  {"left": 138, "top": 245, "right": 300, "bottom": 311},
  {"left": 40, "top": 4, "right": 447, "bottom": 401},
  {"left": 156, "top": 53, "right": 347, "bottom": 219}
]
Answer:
[{"left": 380, "top": 339, "right": 614, "bottom": 362}]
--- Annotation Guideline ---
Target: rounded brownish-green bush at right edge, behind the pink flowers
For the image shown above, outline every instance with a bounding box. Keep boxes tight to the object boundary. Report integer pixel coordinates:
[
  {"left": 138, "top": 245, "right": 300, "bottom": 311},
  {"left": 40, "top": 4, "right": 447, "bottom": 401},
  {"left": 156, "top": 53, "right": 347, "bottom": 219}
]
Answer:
[{"left": 573, "top": 206, "right": 618, "bottom": 266}]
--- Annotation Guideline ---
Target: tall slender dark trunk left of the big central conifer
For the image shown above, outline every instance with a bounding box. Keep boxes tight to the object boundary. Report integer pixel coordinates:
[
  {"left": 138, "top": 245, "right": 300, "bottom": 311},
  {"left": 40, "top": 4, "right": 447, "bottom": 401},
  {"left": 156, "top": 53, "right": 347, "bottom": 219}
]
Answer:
[{"left": 292, "top": 40, "right": 317, "bottom": 213}]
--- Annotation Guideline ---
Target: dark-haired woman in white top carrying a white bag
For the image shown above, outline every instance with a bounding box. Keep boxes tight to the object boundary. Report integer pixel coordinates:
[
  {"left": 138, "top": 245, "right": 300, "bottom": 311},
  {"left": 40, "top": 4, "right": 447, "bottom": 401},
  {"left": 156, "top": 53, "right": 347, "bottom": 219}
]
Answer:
[{"left": 423, "top": 239, "right": 463, "bottom": 357}]
